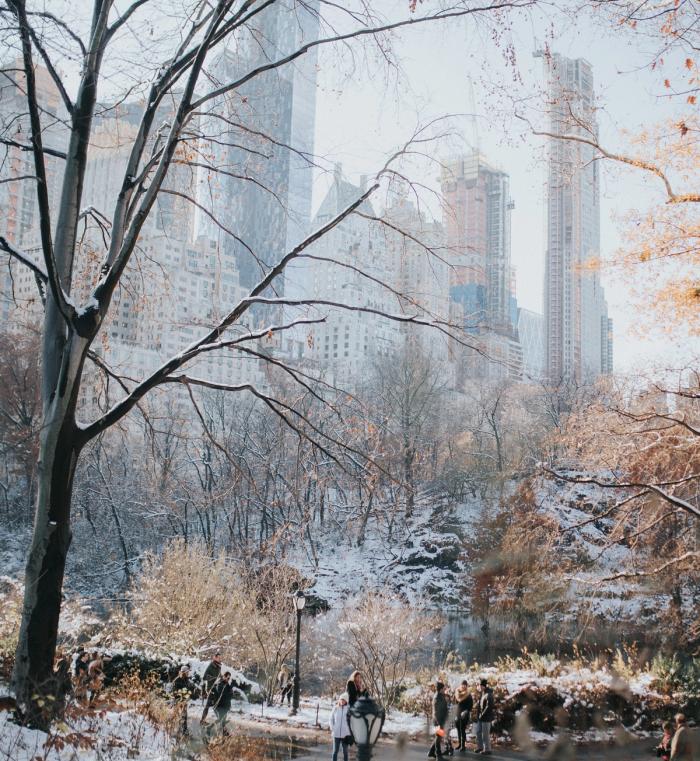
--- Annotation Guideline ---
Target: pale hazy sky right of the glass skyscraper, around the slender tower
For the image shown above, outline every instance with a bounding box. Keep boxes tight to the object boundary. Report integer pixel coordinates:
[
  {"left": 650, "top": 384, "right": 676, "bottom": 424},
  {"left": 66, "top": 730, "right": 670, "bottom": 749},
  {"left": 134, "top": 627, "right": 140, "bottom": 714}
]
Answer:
[{"left": 314, "top": 0, "right": 700, "bottom": 372}]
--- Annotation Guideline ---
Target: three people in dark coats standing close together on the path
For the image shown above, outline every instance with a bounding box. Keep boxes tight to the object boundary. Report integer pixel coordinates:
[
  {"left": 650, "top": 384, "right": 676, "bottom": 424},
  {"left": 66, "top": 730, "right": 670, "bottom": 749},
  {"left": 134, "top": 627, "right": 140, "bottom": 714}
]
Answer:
[{"left": 428, "top": 679, "right": 495, "bottom": 758}]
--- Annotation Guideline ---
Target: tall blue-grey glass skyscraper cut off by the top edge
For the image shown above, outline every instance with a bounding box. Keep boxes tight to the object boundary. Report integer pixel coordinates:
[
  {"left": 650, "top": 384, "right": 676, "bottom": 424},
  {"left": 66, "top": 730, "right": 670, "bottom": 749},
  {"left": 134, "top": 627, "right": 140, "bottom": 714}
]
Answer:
[{"left": 197, "top": 0, "right": 319, "bottom": 289}]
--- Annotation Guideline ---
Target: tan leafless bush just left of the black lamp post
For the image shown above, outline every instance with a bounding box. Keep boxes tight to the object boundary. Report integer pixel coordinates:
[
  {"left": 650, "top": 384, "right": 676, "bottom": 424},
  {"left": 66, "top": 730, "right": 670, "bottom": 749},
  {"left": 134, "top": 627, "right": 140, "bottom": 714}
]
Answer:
[{"left": 118, "top": 540, "right": 302, "bottom": 697}]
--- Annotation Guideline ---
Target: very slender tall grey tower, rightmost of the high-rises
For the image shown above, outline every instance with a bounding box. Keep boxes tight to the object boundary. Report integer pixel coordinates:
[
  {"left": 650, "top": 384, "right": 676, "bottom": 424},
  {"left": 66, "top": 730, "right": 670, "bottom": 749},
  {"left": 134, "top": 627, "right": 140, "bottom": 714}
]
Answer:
[{"left": 538, "top": 53, "right": 612, "bottom": 382}]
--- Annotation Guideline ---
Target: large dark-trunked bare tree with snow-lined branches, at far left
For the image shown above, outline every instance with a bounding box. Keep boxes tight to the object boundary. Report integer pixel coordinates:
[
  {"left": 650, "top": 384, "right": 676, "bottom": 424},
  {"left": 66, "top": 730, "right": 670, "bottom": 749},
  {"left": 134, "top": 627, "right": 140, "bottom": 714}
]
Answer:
[{"left": 0, "top": 0, "right": 531, "bottom": 724}]
